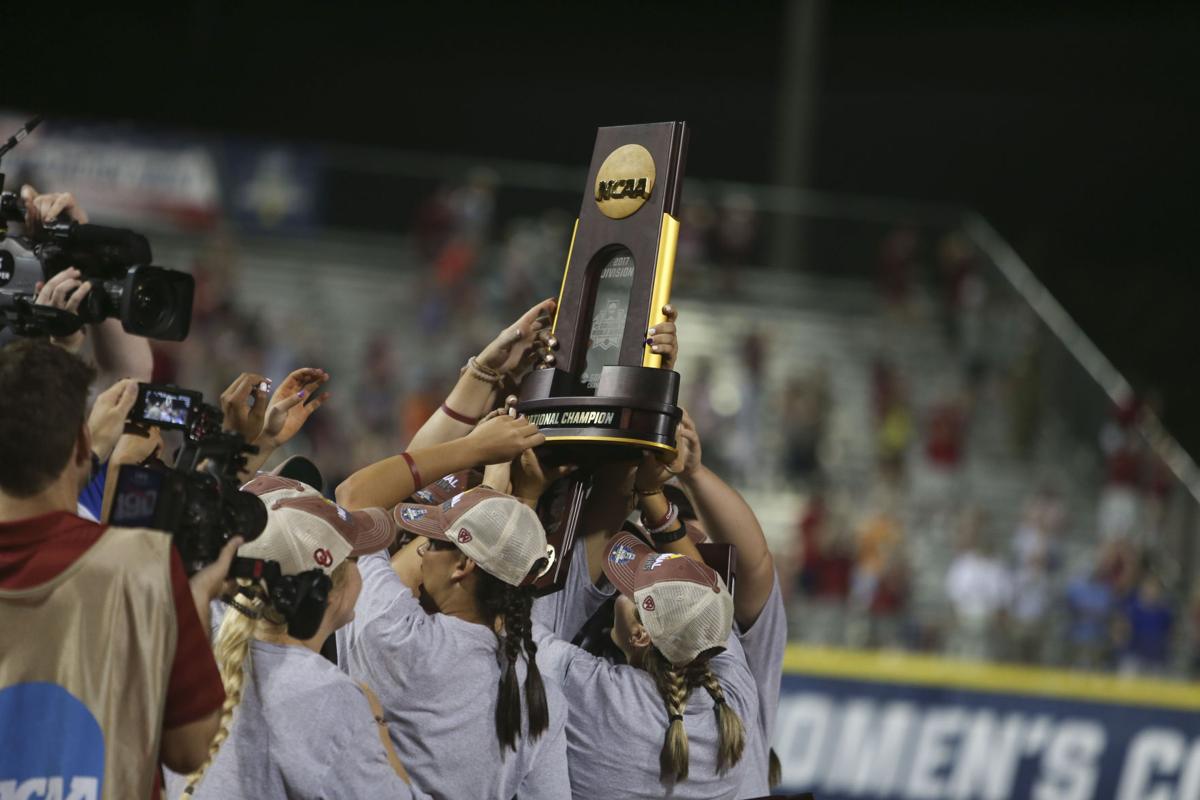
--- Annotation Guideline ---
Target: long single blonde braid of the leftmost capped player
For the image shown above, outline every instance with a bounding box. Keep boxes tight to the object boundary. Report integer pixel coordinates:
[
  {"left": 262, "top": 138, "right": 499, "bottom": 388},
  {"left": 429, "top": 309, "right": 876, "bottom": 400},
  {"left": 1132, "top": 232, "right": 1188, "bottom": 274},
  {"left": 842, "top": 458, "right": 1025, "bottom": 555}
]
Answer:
[{"left": 180, "top": 561, "right": 358, "bottom": 800}]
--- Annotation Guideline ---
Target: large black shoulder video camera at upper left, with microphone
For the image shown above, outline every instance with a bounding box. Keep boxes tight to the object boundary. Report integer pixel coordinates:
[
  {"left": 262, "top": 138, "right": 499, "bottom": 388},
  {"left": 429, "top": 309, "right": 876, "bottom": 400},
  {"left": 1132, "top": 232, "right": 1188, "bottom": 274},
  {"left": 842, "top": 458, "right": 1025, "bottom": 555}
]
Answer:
[{"left": 0, "top": 118, "right": 194, "bottom": 342}]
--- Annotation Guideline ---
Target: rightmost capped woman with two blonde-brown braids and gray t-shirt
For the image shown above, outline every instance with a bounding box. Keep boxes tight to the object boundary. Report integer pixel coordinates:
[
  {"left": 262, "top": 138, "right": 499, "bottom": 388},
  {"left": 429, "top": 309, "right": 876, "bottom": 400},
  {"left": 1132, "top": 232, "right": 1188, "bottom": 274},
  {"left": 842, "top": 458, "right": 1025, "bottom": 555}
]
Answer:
[{"left": 535, "top": 534, "right": 764, "bottom": 799}]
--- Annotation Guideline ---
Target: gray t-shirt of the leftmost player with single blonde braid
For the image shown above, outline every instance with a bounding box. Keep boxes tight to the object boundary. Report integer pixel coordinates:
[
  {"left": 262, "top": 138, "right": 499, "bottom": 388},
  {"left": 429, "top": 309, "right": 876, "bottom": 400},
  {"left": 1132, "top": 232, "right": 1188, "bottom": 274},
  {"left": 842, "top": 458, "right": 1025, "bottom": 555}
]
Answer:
[{"left": 164, "top": 642, "right": 414, "bottom": 800}]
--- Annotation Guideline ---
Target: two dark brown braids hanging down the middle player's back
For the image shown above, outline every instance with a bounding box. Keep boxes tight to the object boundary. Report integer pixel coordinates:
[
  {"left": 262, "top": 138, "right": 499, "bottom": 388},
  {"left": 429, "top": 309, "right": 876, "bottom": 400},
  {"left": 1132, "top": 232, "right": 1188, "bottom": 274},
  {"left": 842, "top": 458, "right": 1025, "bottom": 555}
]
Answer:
[{"left": 475, "top": 570, "right": 550, "bottom": 752}]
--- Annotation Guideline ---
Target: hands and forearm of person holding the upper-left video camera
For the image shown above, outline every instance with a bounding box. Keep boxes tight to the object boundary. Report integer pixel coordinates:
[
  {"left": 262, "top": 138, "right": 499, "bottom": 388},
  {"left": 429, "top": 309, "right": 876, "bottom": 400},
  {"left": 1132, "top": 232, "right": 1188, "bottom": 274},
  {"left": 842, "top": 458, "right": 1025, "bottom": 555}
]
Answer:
[{"left": 0, "top": 185, "right": 154, "bottom": 386}]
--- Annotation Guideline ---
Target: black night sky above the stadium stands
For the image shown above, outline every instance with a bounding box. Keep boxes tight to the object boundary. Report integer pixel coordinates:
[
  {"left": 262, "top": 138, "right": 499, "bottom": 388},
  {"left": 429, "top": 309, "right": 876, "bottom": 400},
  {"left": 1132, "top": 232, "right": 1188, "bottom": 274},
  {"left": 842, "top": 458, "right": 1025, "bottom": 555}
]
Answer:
[{"left": 9, "top": 0, "right": 1200, "bottom": 455}]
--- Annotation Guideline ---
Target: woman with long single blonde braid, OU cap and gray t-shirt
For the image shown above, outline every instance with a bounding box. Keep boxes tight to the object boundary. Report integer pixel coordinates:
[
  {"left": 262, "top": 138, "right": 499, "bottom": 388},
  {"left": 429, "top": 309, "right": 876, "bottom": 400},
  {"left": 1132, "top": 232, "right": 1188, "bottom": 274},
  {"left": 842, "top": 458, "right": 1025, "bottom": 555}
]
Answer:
[{"left": 167, "top": 475, "right": 415, "bottom": 800}]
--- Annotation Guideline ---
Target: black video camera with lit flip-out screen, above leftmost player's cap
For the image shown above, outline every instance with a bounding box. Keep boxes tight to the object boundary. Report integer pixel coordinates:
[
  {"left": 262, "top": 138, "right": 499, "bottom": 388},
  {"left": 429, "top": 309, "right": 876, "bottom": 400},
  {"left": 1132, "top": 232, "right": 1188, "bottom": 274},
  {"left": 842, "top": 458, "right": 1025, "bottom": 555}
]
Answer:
[{"left": 109, "top": 384, "right": 266, "bottom": 575}]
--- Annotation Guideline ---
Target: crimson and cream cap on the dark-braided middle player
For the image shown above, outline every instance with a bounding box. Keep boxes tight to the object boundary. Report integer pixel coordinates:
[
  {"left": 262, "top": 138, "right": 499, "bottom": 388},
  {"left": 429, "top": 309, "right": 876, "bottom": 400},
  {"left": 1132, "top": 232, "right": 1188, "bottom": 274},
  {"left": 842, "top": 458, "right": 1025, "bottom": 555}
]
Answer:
[{"left": 394, "top": 486, "right": 553, "bottom": 587}]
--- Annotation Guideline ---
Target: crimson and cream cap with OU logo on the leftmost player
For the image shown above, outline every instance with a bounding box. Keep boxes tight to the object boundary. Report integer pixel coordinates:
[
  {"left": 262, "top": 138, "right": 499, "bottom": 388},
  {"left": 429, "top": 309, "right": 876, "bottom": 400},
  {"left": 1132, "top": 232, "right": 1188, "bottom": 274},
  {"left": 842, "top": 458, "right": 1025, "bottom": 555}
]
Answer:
[{"left": 238, "top": 474, "right": 396, "bottom": 575}]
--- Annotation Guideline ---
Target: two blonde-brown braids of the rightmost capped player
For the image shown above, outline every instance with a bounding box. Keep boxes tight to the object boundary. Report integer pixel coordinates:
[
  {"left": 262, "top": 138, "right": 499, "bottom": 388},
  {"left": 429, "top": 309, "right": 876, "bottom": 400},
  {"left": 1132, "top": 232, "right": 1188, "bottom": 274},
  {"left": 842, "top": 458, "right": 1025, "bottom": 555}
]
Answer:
[{"left": 643, "top": 645, "right": 745, "bottom": 784}]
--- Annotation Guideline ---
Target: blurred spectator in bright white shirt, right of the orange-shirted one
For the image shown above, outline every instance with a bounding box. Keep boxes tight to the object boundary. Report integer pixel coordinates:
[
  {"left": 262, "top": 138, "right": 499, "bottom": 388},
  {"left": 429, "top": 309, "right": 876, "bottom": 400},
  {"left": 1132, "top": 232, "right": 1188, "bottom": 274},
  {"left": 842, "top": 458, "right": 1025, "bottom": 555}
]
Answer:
[{"left": 946, "top": 509, "right": 1013, "bottom": 661}]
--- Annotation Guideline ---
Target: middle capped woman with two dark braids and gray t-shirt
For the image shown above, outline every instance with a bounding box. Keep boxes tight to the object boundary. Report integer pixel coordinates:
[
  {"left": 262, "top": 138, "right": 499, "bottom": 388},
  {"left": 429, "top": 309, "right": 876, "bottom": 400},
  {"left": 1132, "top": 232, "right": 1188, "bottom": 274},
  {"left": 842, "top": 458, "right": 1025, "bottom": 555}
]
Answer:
[{"left": 340, "top": 486, "right": 571, "bottom": 800}]
